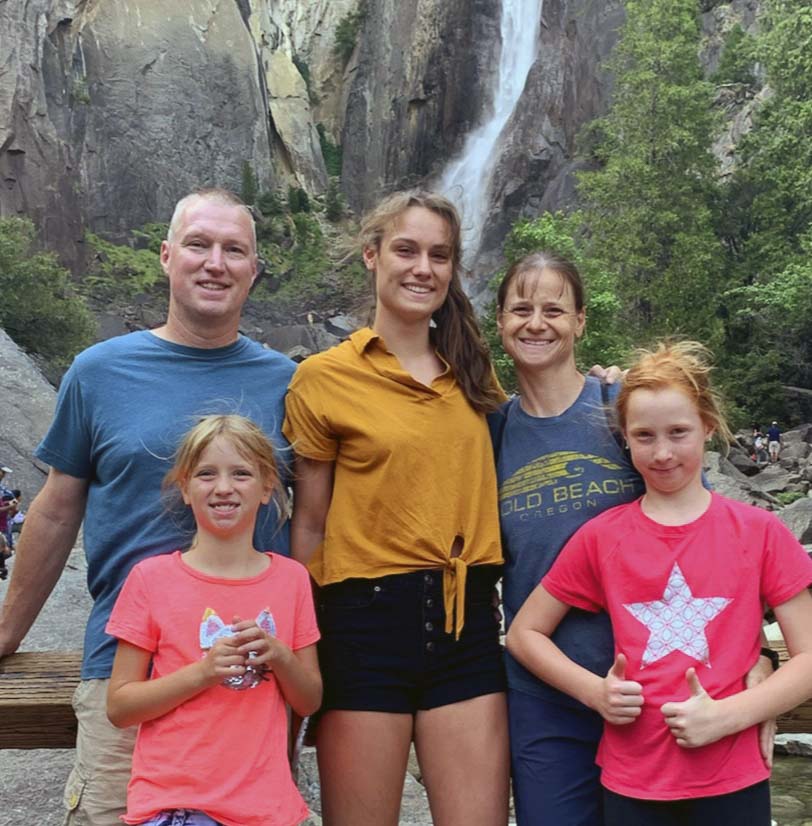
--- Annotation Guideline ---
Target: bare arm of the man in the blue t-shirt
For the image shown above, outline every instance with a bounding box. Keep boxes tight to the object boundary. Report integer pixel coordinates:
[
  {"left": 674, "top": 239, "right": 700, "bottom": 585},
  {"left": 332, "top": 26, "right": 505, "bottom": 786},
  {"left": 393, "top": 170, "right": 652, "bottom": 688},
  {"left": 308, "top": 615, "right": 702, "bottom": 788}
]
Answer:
[{"left": 0, "top": 482, "right": 84, "bottom": 657}]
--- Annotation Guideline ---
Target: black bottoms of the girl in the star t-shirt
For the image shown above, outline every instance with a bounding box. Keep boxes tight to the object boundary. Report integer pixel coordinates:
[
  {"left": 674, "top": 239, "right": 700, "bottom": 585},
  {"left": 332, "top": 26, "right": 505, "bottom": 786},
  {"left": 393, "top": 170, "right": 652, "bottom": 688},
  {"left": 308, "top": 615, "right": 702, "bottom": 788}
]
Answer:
[{"left": 604, "top": 780, "right": 771, "bottom": 826}]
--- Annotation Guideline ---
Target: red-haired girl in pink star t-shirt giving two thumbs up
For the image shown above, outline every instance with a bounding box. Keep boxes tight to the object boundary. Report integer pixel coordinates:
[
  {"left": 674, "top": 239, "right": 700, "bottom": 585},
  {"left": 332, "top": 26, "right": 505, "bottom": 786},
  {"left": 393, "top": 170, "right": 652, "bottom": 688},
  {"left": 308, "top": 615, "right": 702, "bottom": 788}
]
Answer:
[{"left": 507, "top": 342, "right": 812, "bottom": 826}]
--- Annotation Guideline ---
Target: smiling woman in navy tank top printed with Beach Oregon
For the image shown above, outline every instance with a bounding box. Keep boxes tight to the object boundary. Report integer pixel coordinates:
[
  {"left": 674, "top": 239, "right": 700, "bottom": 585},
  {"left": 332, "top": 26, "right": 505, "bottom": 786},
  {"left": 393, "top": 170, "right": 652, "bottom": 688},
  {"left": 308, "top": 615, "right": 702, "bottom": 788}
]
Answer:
[{"left": 490, "top": 252, "right": 772, "bottom": 826}]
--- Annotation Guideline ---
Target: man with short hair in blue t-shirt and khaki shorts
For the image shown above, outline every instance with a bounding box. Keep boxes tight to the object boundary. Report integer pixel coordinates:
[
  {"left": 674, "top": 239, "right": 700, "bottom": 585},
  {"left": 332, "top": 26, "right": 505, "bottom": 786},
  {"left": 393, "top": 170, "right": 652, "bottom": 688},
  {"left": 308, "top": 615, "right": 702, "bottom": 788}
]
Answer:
[{"left": 0, "top": 190, "right": 294, "bottom": 826}]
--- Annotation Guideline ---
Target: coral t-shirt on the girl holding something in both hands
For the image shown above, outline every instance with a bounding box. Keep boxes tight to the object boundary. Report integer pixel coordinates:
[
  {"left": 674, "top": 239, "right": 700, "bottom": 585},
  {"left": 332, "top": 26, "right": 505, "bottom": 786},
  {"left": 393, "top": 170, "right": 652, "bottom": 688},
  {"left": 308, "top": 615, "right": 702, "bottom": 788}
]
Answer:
[{"left": 106, "top": 551, "right": 319, "bottom": 826}]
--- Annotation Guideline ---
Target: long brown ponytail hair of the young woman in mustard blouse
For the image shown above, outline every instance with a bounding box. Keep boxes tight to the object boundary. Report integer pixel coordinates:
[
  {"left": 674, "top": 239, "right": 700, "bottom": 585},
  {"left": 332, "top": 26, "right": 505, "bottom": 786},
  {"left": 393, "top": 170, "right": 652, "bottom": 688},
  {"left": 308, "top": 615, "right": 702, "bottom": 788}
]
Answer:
[{"left": 358, "top": 189, "right": 505, "bottom": 413}]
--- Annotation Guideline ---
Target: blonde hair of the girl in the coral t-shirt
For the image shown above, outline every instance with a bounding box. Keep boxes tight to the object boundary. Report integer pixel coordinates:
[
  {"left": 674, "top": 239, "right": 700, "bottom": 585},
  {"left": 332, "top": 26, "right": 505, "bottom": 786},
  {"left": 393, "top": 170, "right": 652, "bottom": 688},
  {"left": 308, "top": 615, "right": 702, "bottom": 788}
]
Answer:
[{"left": 163, "top": 413, "right": 288, "bottom": 517}]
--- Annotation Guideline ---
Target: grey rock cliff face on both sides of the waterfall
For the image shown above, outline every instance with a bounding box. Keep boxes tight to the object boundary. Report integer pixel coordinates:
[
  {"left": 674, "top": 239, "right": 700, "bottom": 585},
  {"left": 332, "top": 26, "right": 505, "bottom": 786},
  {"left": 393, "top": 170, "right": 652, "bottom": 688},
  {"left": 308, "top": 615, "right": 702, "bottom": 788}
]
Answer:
[{"left": 0, "top": 0, "right": 760, "bottom": 280}]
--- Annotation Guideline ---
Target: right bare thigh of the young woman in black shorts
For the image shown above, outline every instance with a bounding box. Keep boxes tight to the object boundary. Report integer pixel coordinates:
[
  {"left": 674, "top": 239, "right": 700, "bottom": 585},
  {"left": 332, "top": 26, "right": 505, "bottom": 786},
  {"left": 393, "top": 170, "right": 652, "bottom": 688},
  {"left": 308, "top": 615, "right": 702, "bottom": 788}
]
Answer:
[{"left": 415, "top": 694, "right": 510, "bottom": 826}]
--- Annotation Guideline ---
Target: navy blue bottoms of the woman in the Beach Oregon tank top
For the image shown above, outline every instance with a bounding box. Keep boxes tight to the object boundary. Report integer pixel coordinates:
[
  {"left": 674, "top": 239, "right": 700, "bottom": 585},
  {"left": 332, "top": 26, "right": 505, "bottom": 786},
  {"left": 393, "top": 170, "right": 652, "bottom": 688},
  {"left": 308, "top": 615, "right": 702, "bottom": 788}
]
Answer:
[{"left": 508, "top": 689, "right": 604, "bottom": 826}]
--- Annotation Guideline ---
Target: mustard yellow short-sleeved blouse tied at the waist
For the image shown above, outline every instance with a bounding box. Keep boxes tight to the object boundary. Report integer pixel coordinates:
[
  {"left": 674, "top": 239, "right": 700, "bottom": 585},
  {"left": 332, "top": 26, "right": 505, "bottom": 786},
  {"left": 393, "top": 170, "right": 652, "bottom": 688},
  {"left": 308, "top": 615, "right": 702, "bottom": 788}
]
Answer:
[{"left": 283, "top": 328, "right": 502, "bottom": 637}]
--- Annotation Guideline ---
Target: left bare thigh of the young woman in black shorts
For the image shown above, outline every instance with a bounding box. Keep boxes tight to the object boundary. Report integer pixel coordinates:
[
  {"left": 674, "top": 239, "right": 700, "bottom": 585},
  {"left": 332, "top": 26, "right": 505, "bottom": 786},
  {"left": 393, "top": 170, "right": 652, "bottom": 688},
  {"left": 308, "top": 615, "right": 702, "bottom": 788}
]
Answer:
[{"left": 316, "top": 711, "right": 414, "bottom": 826}]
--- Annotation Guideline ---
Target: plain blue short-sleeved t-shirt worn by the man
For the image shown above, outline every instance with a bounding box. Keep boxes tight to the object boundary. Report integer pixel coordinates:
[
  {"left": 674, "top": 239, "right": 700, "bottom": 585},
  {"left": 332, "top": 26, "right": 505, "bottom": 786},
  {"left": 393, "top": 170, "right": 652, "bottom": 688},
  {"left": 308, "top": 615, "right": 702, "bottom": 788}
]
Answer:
[{"left": 36, "top": 331, "right": 295, "bottom": 679}]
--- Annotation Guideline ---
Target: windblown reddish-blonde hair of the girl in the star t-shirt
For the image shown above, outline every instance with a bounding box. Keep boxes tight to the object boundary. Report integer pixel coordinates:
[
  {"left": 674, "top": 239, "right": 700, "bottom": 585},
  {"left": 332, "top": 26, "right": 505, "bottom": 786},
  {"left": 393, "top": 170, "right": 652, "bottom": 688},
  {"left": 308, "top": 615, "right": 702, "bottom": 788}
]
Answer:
[{"left": 615, "top": 341, "right": 734, "bottom": 444}]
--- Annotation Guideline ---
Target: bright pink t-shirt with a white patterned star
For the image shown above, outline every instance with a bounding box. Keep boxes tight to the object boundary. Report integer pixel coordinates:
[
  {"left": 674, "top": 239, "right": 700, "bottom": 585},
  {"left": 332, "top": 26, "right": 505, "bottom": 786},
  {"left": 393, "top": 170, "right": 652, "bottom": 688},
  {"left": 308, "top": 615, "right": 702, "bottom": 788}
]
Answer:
[{"left": 542, "top": 494, "right": 812, "bottom": 800}]
